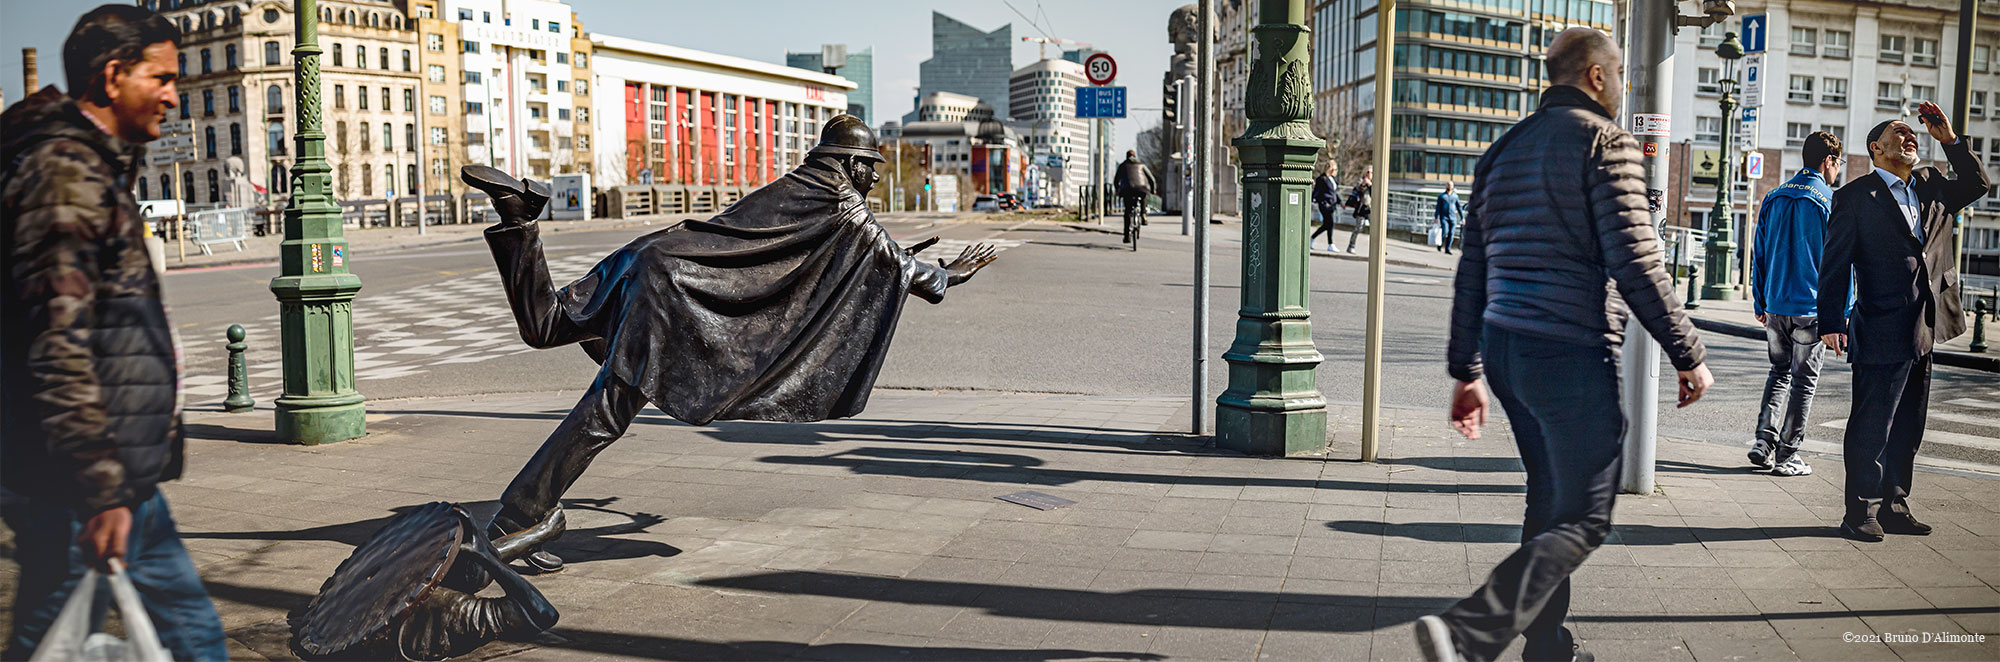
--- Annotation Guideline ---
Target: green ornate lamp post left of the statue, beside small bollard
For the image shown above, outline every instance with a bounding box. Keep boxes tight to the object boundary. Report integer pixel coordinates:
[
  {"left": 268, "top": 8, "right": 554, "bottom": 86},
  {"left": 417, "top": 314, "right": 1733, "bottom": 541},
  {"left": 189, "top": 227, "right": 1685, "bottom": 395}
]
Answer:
[{"left": 270, "top": 0, "right": 366, "bottom": 444}]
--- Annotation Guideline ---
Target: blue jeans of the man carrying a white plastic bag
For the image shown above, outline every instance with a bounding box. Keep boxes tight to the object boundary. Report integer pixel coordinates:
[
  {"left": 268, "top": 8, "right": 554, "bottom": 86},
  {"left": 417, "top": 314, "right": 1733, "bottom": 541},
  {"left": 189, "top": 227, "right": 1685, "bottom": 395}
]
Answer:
[{"left": 0, "top": 494, "right": 228, "bottom": 660}]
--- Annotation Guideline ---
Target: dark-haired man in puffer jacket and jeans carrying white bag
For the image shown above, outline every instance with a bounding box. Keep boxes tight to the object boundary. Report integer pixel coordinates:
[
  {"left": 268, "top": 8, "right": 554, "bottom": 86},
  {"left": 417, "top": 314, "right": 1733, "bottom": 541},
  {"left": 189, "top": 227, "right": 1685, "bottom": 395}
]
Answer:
[{"left": 0, "top": 4, "right": 228, "bottom": 660}]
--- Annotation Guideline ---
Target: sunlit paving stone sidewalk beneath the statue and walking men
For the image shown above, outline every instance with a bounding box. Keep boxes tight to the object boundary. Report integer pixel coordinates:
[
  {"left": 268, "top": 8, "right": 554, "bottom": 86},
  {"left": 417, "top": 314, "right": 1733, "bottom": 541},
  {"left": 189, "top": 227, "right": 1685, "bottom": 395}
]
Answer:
[{"left": 0, "top": 390, "right": 2000, "bottom": 660}]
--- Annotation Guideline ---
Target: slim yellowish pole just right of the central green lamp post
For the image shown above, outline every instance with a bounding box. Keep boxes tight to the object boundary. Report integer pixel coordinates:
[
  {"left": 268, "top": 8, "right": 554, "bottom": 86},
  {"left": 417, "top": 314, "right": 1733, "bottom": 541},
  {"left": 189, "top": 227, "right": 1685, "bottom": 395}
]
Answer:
[{"left": 1362, "top": 0, "right": 1396, "bottom": 462}]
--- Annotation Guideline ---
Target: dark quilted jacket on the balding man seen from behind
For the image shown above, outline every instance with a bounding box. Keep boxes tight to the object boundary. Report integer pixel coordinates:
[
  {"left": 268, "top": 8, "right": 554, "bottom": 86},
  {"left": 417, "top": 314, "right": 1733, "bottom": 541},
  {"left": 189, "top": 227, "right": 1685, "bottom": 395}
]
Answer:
[{"left": 1446, "top": 86, "right": 1704, "bottom": 382}]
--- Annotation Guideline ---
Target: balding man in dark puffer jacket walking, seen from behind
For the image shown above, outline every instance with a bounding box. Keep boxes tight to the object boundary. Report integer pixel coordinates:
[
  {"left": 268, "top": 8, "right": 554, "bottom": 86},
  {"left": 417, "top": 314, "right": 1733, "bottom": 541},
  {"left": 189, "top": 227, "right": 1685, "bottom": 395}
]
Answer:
[{"left": 1418, "top": 28, "right": 1714, "bottom": 660}]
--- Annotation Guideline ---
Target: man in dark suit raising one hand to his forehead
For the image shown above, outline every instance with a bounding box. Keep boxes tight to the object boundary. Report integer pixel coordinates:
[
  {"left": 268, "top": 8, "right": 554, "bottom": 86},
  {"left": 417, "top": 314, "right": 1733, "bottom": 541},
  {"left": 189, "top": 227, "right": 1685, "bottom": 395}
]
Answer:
[{"left": 1818, "top": 102, "right": 1988, "bottom": 542}]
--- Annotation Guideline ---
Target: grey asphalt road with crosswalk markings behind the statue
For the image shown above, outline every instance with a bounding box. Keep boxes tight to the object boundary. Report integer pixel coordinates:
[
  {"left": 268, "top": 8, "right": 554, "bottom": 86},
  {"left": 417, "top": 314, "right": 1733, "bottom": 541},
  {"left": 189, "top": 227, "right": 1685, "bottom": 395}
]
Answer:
[{"left": 166, "top": 214, "right": 2000, "bottom": 466}]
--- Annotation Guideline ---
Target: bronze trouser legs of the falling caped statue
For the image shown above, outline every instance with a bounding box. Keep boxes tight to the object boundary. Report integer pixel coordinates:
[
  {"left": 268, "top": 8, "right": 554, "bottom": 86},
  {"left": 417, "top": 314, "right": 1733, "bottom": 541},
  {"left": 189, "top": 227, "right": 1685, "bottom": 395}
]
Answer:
[{"left": 486, "top": 224, "right": 646, "bottom": 532}]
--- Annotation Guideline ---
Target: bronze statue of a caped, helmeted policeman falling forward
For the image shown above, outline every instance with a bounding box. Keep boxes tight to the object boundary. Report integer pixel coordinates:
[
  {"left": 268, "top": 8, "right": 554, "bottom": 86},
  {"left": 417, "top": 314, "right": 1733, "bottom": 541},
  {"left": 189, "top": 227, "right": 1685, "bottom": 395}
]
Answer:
[{"left": 460, "top": 114, "right": 994, "bottom": 572}]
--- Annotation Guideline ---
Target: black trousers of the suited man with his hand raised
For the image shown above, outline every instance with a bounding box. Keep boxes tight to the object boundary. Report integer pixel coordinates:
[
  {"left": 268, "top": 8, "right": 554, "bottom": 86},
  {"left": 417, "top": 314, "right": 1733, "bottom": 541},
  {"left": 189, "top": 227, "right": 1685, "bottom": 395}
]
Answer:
[{"left": 1840, "top": 352, "right": 1930, "bottom": 522}]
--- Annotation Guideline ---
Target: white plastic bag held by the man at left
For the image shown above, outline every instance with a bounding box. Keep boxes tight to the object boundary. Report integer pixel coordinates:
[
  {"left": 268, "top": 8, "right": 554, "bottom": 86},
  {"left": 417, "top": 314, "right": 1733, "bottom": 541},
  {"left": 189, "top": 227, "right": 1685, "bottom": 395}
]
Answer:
[{"left": 28, "top": 558, "right": 172, "bottom": 662}]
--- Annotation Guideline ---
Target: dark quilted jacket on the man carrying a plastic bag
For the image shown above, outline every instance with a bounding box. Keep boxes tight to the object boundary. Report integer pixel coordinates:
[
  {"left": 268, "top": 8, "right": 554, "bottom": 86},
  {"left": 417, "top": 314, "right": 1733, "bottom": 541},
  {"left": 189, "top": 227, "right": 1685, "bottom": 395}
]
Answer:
[{"left": 0, "top": 88, "right": 182, "bottom": 512}]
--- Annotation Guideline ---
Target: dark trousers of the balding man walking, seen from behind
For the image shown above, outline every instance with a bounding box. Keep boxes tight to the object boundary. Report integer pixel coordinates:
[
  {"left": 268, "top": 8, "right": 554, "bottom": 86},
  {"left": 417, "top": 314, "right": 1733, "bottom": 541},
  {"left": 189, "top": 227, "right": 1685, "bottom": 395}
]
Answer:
[{"left": 1442, "top": 326, "right": 1624, "bottom": 660}]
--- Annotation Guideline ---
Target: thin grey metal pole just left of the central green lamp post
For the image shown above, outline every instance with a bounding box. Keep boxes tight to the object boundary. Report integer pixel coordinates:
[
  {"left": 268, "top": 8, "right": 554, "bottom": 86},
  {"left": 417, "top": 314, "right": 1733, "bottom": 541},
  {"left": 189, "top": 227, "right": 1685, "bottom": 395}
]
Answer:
[{"left": 1180, "top": 0, "right": 1220, "bottom": 436}]
